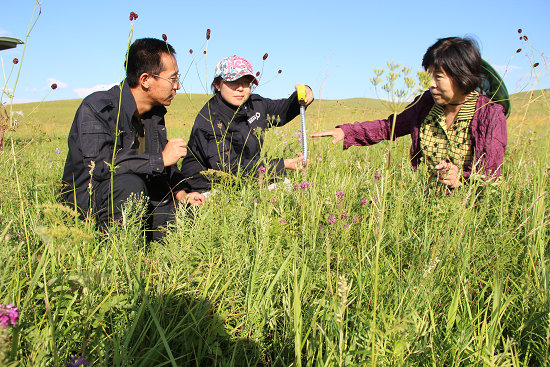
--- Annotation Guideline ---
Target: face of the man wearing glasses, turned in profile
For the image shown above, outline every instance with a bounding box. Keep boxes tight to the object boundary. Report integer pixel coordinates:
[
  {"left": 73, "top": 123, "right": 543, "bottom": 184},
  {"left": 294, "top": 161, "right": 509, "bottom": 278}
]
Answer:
[{"left": 148, "top": 52, "right": 181, "bottom": 106}]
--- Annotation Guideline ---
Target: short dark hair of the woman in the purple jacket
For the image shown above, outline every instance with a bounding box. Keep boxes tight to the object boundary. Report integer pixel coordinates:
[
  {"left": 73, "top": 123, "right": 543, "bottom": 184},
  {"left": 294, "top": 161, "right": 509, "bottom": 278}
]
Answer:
[{"left": 422, "top": 37, "right": 481, "bottom": 93}]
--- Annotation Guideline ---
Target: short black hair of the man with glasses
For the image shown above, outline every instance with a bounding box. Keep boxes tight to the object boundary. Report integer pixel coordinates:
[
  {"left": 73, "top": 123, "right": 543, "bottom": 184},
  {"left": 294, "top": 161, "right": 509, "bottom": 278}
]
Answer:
[{"left": 125, "top": 38, "right": 176, "bottom": 88}]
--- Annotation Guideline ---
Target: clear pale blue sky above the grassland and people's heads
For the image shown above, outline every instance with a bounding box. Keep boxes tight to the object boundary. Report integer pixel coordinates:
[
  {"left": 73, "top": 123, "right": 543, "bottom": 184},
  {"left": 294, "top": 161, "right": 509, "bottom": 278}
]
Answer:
[{"left": 0, "top": 0, "right": 550, "bottom": 103}]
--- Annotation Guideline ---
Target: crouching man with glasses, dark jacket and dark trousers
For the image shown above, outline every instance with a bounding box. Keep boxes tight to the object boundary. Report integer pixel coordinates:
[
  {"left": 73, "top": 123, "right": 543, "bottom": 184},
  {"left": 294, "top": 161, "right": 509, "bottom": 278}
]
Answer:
[{"left": 62, "top": 38, "right": 204, "bottom": 239}]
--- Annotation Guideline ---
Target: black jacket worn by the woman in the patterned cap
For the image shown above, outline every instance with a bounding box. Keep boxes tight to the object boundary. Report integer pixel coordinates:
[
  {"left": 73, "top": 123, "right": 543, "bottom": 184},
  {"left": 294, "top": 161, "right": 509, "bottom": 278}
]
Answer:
[{"left": 181, "top": 92, "right": 300, "bottom": 192}]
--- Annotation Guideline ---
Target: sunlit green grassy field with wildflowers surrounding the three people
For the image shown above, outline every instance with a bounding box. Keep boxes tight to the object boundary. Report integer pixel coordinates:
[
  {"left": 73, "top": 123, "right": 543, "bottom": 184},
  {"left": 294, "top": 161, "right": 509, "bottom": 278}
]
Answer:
[{"left": 0, "top": 90, "right": 550, "bottom": 366}]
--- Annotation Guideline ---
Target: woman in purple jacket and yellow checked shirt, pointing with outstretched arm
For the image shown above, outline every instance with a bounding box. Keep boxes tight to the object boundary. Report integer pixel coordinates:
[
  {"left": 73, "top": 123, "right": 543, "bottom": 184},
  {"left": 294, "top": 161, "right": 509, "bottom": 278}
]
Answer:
[{"left": 311, "top": 37, "right": 507, "bottom": 188}]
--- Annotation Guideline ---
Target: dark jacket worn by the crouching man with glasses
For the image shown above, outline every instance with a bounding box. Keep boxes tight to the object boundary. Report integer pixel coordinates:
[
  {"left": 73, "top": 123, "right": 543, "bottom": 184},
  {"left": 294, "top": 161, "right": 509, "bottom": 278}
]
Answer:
[{"left": 62, "top": 83, "right": 181, "bottom": 216}]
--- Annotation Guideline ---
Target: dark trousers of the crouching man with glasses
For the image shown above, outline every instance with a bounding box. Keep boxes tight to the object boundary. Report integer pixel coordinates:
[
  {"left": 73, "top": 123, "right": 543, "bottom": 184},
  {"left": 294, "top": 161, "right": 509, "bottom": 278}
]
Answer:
[{"left": 94, "top": 173, "right": 176, "bottom": 241}]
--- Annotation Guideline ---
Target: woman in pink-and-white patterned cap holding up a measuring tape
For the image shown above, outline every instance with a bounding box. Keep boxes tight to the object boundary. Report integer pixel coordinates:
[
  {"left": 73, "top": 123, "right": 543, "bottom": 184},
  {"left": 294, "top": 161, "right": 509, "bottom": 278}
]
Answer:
[{"left": 181, "top": 56, "right": 313, "bottom": 192}]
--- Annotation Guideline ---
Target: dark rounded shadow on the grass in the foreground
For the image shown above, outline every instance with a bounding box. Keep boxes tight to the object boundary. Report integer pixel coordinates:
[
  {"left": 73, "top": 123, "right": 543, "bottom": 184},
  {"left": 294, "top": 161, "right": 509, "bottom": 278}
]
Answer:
[{"left": 124, "top": 293, "right": 265, "bottom": 366}]
